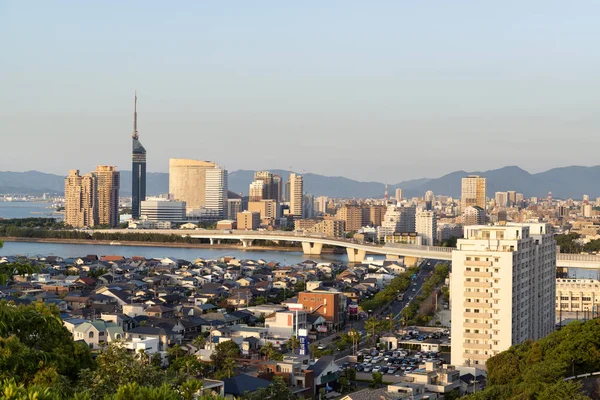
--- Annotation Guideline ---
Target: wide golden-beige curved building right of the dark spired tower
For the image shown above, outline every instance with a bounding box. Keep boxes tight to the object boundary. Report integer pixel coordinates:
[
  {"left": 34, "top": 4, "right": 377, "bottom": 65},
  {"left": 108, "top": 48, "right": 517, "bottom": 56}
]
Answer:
[{"left": 169, "top": 158, "right": 218, "bottom": 212}]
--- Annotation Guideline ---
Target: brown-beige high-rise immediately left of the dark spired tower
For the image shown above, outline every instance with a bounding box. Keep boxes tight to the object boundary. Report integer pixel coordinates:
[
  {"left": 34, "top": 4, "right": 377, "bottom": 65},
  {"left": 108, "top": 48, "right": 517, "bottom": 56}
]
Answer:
[{"left": 94, "top": 165, "right": 121, "bottom": 227}]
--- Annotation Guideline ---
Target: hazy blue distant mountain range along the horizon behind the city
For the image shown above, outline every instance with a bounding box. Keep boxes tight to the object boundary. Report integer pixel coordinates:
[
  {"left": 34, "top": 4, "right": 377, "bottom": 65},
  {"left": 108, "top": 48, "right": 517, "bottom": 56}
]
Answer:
[{"left": 0, "top": 165, "right": 600, "bottom": 199}]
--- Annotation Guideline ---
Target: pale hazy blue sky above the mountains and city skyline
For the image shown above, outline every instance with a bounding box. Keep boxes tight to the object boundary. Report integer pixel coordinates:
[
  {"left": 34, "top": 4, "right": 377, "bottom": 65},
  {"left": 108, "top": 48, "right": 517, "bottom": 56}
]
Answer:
[{"left": 0, "top": 0, "right": 600, "bottom": 183}]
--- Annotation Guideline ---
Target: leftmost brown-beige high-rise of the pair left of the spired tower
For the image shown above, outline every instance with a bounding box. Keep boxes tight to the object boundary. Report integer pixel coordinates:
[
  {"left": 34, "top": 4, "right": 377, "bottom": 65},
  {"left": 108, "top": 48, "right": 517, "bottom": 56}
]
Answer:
[{"left": 65, "top": 169, "right": 97, "bottom": 228}]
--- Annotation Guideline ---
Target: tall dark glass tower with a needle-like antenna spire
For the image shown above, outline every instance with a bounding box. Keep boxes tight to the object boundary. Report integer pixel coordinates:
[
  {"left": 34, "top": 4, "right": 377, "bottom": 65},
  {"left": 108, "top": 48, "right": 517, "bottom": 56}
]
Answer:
[{"left": 131, "top": 94, "right": 146, "bottom": 219}]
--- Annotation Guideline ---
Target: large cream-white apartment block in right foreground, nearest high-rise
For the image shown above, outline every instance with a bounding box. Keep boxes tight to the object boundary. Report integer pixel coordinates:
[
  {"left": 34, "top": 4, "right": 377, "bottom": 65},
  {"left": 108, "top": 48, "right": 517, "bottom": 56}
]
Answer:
[{"left": 450, "top": 223, "right": 556, "bottom": 366}]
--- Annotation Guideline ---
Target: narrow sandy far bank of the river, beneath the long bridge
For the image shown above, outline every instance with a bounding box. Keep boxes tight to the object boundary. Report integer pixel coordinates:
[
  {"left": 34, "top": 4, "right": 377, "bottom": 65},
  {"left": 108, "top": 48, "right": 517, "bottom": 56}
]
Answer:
[{"left": 0, "top": 237, "right": 337, "bottom": 254}]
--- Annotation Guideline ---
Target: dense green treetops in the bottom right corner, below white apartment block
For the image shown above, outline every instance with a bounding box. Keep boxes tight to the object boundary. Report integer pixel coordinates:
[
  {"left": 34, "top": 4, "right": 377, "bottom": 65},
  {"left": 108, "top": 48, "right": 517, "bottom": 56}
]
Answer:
[{"left": 468, "top": 320, "right": 600, "bottom": 400}]
